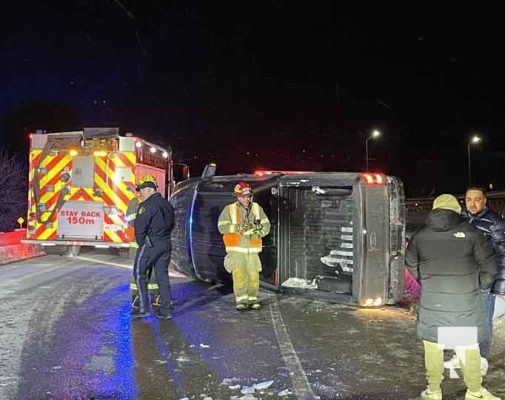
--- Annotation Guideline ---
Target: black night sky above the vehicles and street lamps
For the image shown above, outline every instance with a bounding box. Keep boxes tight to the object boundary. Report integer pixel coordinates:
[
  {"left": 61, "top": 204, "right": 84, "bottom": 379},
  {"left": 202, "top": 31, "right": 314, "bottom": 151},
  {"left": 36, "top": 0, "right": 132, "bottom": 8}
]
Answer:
[{"left": 0, "top": 0, "right": 505, "bottom": 196}]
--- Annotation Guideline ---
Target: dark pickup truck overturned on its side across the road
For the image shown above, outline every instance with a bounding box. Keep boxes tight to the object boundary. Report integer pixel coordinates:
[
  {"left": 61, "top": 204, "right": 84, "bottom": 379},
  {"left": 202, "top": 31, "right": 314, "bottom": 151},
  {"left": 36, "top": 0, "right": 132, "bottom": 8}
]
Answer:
[{"left": 171, "top": 172, "right": 405, "bottom": 306}]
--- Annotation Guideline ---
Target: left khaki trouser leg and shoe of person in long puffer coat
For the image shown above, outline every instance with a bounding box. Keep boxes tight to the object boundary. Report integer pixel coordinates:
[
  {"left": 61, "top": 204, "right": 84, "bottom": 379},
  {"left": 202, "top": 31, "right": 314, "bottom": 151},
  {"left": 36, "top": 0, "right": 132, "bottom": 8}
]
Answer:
[{"left": 421, "top": 340, "right": 444, "bottom": 400}]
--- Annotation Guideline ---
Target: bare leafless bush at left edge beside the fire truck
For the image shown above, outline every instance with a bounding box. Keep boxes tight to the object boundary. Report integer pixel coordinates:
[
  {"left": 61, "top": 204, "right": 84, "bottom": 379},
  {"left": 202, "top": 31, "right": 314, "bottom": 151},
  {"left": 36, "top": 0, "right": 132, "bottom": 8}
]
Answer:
[{"left": 0, "top": 151, "right": 28, "bottom": 232}]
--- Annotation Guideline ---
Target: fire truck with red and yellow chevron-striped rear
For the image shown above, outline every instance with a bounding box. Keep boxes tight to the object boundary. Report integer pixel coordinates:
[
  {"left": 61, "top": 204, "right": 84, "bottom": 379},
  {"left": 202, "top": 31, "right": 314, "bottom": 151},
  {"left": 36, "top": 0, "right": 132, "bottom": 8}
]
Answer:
[{"left": 23, "top": 128, "right": 174, "bottom": 256}]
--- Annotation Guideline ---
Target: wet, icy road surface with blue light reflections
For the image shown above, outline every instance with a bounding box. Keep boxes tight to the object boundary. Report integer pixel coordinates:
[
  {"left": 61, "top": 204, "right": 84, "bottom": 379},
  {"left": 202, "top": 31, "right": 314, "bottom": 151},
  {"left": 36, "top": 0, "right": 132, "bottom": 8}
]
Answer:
[{"left": 0, "top": 252, "right": 505, "bottom": 400}]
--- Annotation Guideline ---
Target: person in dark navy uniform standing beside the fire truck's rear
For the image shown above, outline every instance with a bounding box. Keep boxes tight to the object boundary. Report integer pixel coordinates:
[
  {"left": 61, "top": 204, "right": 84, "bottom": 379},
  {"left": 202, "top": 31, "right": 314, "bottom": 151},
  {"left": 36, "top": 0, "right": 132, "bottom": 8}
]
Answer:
[{"left": 132, "top": 175, "right": 174, "bottom": 319}]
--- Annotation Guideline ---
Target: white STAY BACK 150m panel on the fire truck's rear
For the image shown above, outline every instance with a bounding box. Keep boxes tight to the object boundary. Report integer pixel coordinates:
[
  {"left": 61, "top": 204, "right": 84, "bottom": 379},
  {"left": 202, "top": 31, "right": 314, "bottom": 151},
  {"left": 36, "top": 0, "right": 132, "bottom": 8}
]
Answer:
[{"left": 58, "top": 201, "right": 103, "bottom": 239}]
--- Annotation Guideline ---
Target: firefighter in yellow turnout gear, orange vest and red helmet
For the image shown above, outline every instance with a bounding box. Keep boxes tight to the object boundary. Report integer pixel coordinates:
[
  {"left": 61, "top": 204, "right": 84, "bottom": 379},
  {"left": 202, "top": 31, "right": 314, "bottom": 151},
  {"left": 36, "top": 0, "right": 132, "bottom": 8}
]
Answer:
[{"left": 218, "top": 182, "right": 270, "bottom": 311}]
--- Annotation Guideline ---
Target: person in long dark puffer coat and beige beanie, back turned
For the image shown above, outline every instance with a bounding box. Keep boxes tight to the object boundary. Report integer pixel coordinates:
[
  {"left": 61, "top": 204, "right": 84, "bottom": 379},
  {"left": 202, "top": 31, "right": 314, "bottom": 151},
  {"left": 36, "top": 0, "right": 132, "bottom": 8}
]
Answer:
[{"left": 406, "top": 194, "right": 499, "bottom": 400}]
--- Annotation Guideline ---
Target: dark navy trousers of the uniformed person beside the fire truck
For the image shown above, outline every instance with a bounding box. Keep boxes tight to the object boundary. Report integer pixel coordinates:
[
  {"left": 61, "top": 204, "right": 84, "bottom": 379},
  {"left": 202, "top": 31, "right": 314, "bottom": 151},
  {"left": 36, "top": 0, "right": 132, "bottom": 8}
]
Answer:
[{"left": 133, "top": 241, "right": 172, "bottom": 313}]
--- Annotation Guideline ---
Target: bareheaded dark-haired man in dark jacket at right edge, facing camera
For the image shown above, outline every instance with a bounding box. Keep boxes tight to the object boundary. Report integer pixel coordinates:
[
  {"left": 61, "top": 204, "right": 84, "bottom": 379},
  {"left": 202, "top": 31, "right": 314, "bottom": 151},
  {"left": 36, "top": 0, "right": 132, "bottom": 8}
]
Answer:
[{"left": 463, "top": 187, "right": 505, "bottom": 364}]
